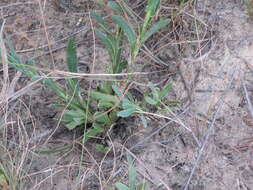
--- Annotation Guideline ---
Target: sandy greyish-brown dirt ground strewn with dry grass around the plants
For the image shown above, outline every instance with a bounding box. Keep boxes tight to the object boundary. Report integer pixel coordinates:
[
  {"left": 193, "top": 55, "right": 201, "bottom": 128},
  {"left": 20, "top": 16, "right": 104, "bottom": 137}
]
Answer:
[{"left": 0, "top": 0, "right": 253, "bottom": 190}]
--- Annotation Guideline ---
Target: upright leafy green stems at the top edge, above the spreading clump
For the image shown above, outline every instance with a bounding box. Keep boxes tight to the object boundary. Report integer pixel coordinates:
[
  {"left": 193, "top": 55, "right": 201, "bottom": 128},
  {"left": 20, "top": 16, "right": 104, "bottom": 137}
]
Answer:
[{"left": 93, "top": 0, "right": 170, "bottom": 65}]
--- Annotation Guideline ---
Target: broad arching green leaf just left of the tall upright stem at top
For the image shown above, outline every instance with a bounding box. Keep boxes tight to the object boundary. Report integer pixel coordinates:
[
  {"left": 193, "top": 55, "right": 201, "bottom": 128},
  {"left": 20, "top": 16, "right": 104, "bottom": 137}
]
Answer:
[{"left": 112, "top": 16, "right": 136, "bottom": 48}]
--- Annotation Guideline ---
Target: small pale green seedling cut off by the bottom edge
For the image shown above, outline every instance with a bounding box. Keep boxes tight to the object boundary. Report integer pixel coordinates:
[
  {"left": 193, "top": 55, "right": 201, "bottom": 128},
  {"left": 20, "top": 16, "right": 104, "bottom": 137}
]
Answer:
[{"left": 115, "top": 155, "right": 148, "bottom": 190}]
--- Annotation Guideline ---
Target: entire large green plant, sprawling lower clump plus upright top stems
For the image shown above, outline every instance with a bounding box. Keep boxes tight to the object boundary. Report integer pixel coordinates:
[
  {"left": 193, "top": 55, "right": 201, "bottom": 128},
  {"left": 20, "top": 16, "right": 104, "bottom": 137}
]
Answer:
[{"left": 1, "top": 0, "right": 176, "bottom": 145}]
